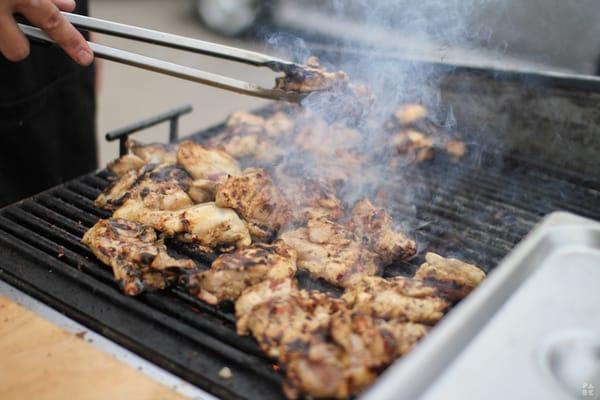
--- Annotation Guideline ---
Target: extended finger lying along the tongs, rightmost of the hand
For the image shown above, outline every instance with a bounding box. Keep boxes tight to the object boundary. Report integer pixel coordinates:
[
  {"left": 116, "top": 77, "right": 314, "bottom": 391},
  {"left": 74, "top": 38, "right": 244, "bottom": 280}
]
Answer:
[{"left": 16, "top": 0, "right": 94, "bottom": 66}]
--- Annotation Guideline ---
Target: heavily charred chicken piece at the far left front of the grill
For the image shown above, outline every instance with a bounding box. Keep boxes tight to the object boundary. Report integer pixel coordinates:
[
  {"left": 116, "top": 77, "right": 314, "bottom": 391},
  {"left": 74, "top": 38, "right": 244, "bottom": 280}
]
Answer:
[{"left": 82, "top": 219, "right": 196, "bottom": 296}]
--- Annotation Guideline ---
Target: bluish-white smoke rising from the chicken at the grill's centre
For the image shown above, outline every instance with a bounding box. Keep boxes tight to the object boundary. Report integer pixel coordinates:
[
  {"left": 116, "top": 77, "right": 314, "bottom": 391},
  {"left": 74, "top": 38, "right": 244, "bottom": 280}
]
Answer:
[{"left": 256, "top": 0, "right": 505, "bottom": 255}]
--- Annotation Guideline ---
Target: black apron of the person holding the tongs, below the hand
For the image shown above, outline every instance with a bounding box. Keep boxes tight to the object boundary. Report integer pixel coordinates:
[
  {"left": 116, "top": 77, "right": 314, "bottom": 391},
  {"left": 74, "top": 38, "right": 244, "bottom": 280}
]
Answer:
[{"left": 0, "top": 0, "right": 97, "bottom": 207}]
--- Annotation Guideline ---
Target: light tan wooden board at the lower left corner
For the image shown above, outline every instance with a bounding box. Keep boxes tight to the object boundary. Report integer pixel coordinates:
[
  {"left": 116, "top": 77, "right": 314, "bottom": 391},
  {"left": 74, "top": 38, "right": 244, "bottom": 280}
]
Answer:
[{"left": 0, "top": 296, "right": 184, "bottom": 400}]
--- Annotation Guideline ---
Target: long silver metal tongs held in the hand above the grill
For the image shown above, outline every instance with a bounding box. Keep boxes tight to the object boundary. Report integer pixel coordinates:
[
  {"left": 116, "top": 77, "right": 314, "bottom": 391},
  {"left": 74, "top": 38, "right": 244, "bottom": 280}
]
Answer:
[{"left": 19, "top": 12, "right": 306, "bottom": 102}]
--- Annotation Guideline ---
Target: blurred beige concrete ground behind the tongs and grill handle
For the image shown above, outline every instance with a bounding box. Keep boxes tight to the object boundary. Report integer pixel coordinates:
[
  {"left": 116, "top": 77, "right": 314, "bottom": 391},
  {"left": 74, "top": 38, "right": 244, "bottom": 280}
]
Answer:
[{"left": 90, "top": 0, "right": 274, "bottom": 166}]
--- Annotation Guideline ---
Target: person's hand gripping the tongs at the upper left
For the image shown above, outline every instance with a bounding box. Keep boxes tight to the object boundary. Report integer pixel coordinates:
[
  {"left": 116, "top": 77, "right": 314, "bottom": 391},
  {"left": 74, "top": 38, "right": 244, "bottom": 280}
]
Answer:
[{"left": 0, "top": 0, "right": 94, "bottom": 66}]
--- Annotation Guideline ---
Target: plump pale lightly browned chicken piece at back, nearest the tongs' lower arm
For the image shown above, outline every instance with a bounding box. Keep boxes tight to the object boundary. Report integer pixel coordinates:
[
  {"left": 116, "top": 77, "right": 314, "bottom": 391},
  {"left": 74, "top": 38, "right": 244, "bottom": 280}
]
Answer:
[{"left": 177, "top": 140, "right": 242, "bottom": 182}]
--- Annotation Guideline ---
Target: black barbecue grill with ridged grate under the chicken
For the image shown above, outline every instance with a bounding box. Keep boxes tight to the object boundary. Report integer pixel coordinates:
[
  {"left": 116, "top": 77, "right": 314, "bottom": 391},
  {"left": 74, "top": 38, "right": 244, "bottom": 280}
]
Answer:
[{"left": 0, "top": 57, "right": 600, "bottom": 399}]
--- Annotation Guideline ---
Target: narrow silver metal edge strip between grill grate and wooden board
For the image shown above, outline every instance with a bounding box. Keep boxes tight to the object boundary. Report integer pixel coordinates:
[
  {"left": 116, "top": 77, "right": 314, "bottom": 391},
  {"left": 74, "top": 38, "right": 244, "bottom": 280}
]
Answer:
[{"left": 0, "top": 280, "right": 216, "bottom": 400}]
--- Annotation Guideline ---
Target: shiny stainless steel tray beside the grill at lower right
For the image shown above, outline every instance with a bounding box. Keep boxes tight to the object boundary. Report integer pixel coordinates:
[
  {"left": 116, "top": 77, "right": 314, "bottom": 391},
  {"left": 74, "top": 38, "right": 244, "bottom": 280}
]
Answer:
[{"left": 363, "top": 212, "right": 600, "bottom": 400}]
